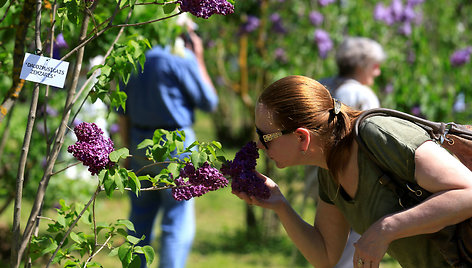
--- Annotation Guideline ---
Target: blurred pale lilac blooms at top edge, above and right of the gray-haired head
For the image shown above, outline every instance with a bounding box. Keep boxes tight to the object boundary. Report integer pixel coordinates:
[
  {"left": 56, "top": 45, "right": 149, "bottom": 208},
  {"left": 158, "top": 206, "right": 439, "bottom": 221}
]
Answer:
[{"left": 374, "top": 0, "right": 424, "bottom": 36}]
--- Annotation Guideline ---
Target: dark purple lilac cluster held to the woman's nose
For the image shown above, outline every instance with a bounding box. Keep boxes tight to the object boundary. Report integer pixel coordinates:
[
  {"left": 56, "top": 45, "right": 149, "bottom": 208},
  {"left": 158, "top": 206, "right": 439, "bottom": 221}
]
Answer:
[{"left": 221, "top": 142, "right": 270, "bottom": 199}]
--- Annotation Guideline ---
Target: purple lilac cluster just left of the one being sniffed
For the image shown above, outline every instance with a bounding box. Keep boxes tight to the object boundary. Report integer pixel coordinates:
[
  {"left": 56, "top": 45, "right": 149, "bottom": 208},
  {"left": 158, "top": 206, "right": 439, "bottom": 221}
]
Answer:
[{"left": 172, "top": 162, "right": 228, "bottom": 201}]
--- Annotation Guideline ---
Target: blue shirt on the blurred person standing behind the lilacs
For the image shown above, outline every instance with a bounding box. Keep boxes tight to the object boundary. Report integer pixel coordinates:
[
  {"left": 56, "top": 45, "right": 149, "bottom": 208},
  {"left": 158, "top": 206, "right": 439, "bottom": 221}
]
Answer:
[{"left": 121, "top": 46, "right": 218, "bottom": 128}]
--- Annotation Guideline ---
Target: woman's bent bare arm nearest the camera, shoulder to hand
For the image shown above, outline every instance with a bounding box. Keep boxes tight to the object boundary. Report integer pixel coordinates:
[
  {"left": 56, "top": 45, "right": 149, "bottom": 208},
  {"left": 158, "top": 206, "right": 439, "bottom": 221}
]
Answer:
[{"left": 355, "top": 141, "right": 472, "bottom": 267}]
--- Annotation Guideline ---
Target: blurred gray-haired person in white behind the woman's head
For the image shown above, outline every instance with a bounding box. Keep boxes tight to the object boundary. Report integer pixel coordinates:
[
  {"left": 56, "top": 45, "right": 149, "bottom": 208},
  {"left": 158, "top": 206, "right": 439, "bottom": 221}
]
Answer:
[{"left": 320, "top": 37, "right": 386, "bottom": 110}]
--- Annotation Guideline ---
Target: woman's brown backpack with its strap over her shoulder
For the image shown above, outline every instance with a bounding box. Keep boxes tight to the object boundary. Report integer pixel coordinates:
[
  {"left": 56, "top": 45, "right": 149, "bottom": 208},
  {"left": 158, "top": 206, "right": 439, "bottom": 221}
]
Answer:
[{"left": 354, "top": 108, "right": 472, "bottom": 267}]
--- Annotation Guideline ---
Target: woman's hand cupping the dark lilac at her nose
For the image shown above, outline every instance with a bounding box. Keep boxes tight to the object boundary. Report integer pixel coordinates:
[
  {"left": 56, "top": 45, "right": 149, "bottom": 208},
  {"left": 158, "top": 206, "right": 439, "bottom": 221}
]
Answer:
[{"left": 232, "top": 171, "right": 286, "bottom": 210}]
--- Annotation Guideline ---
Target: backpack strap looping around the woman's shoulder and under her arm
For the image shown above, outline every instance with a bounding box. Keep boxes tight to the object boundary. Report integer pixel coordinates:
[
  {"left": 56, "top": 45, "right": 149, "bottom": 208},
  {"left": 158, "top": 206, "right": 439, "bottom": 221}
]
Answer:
[{"left": 354, "top": 108, "right": 434, "bottom": 208}]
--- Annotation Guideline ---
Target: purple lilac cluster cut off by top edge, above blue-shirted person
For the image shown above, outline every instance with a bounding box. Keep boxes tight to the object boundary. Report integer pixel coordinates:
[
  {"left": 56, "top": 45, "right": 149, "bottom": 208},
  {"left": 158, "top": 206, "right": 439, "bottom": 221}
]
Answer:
[{"left": 177, "top": 0, "right": 234, "bottom": 19}]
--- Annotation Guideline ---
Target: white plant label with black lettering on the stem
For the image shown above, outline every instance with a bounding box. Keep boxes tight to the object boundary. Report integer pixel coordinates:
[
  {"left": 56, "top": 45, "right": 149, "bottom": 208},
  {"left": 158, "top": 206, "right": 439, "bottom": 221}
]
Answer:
[{"left": 20, "top": 53, "right": 69, "bottom": 88}]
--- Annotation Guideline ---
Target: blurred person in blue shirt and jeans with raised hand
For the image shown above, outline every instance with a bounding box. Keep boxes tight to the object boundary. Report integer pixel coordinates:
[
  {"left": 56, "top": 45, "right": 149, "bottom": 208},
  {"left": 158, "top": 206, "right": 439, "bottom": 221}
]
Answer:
[{"left": 120, "top": 23, "right": 218, "bottom": 268}]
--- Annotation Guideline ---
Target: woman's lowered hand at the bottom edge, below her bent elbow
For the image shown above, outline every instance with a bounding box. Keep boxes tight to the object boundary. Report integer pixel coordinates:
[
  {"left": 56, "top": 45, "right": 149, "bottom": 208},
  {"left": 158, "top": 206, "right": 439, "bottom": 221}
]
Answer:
[{"left": 353, "top": 219, "right": 390, "bottom": 268}]
